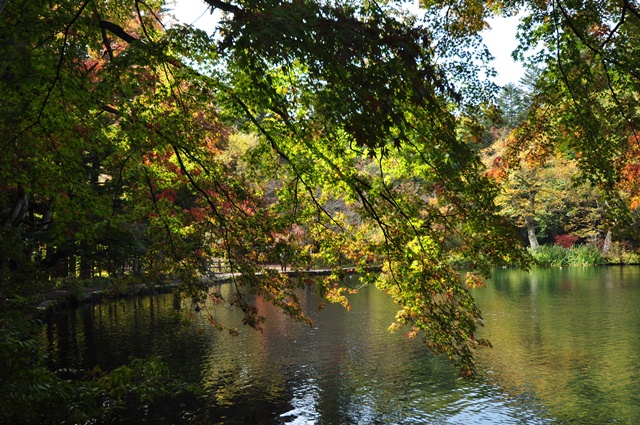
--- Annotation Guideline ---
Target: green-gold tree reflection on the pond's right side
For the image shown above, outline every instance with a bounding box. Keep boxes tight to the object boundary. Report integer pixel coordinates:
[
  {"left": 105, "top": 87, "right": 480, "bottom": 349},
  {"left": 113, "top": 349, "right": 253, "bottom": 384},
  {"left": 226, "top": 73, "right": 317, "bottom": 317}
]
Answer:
[{"left": 475, "top": 268, "right": 640, "bottom": 423}]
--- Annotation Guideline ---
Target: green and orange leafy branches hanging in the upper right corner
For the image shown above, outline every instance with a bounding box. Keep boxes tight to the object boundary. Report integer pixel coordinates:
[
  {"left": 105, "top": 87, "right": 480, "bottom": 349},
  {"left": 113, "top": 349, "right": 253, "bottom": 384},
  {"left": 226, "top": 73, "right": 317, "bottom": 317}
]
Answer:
[{"left": 510, "top": 1, "right": 640, "bottom": 242}]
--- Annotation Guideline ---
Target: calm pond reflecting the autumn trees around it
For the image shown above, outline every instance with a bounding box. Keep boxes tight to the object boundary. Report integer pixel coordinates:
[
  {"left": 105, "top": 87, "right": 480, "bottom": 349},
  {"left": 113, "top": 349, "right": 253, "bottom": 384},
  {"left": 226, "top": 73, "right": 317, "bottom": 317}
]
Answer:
[{"left": 47, "top": 267, "right": 640, "bottom": 424}]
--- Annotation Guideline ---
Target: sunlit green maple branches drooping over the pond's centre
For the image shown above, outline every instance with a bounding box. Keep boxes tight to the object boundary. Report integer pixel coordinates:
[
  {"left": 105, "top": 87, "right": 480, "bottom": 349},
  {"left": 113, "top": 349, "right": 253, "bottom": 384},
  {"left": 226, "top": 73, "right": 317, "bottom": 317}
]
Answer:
[{"left": 211, "top": 3, "right": 536, "bottom": 372}]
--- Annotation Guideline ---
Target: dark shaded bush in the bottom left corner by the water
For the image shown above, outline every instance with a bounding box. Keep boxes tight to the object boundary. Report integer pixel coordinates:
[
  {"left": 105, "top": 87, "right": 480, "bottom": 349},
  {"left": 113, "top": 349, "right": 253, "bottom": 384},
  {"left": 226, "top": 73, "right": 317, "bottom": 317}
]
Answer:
[{"left": 0, "top": 317, "right": 193, "bottom": 425}]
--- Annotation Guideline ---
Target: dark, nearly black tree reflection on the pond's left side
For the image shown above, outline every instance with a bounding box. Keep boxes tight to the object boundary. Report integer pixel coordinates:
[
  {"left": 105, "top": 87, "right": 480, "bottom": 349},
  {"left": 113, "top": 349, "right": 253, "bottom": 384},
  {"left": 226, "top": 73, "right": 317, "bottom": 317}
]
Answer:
[{"left": 47, "top": 295, "right": 210, "bottom": 374}]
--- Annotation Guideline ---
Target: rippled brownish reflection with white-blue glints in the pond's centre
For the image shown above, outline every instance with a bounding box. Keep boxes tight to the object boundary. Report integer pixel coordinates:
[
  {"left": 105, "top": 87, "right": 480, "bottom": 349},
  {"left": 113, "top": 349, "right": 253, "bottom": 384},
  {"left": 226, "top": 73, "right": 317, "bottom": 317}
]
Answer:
[{"left": 203, "top": 282, "right": 476, "bottom": 423}]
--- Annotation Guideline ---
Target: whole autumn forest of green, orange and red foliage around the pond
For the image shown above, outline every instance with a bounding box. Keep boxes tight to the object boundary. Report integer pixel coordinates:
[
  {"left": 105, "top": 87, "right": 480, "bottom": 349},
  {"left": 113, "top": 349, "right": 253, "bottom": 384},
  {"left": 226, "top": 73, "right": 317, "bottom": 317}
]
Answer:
[{"left": 0, "top": 0, "right": 640, "bottom": 417}]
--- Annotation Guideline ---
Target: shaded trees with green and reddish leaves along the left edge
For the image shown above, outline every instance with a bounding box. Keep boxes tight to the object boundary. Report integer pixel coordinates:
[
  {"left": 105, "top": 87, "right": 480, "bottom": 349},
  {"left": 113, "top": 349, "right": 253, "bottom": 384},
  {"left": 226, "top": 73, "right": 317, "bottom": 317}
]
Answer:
[{"left": 0, "top": 2, "right": 225, "bottom": 292}]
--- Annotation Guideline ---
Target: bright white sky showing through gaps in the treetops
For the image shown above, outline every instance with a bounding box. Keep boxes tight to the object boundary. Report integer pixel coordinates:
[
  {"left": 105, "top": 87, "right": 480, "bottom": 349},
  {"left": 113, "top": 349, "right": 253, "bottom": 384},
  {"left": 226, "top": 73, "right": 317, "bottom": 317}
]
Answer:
[{"left": 173, "top": 0, "right": 525, "bottom": 86}]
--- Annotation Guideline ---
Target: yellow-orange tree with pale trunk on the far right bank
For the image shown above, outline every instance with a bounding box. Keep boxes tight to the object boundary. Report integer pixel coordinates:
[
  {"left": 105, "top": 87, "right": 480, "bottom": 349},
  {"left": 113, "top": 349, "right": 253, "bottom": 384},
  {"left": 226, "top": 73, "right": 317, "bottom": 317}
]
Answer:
[{"left": 484, "top": 134, "right": 607, "bottom": 249}]
